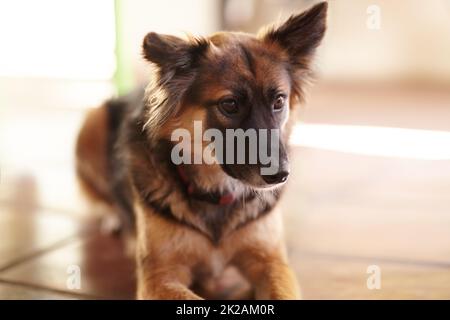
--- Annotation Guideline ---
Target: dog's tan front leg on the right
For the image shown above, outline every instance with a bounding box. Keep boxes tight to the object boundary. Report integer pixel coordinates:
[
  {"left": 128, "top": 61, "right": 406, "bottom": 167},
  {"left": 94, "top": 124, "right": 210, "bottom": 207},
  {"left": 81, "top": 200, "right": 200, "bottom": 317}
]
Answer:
[{"left": 237, "top": 250, "right": 300, "bottom": 300}]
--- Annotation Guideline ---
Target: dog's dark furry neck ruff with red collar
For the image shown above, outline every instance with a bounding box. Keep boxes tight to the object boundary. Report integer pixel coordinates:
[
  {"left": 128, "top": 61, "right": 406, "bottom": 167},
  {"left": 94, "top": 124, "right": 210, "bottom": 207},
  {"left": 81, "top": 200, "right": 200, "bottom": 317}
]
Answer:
[{"left": 138, "top": 135, "right": 282, "bottom": 243}]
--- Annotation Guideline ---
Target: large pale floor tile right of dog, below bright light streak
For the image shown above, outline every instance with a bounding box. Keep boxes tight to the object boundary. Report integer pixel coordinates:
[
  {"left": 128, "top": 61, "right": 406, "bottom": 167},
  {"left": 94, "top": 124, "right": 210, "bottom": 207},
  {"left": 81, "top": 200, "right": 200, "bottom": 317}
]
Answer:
[{"left": 282, "top": 148, "right": 450, "bottom": 264}]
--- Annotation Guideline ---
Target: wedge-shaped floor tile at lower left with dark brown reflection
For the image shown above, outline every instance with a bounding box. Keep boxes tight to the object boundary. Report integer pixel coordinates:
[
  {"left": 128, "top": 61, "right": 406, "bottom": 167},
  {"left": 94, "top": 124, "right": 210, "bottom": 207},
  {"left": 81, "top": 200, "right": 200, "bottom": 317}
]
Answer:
[{"left": 0, "top": 234, "right": 135, "bottom": 299}]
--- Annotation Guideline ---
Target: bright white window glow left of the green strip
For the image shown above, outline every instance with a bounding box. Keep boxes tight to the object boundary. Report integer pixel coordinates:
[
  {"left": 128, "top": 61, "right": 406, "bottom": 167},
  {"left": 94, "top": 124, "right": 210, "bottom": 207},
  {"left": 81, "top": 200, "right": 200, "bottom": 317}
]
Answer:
[{"left": 0, "top": 0, "right": 115, "bottom": 80}]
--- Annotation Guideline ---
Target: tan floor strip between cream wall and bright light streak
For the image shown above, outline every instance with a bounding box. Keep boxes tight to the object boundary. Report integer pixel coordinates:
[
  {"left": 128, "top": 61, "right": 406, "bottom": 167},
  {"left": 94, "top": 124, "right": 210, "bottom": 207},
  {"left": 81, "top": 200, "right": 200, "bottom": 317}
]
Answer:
[{"left": 300, "top": 82, "right": 450, "bottom": 131}]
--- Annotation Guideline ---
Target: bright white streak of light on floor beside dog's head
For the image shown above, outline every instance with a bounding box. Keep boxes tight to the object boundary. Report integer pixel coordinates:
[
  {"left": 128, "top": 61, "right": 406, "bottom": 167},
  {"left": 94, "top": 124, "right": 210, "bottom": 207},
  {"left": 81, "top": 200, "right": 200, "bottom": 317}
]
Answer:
[{"left": 291, "top": 123, "right": 450, "bottom": 160}]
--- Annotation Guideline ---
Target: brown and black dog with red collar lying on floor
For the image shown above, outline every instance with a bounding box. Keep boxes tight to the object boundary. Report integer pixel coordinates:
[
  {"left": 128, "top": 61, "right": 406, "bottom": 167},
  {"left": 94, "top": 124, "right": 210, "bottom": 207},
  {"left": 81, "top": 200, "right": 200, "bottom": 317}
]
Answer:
[{"left": 77, "top": 3, "right": 327, "bottom": 299}]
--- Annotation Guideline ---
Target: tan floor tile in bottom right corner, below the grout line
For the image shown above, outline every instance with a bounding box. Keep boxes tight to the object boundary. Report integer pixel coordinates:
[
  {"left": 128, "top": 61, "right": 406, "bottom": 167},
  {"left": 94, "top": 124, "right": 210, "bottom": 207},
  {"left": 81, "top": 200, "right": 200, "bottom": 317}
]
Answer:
[{"left": 291, "top": 255, "right": 450, "bottom": 299}]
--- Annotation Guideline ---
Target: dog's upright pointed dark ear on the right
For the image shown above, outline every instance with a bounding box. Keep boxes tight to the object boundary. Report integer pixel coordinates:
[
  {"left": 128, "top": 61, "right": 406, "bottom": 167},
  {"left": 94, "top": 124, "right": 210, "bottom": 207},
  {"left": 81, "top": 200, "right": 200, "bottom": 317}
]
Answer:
[{"left": 263, "top": 2, "right": 328, "bottom": 64}]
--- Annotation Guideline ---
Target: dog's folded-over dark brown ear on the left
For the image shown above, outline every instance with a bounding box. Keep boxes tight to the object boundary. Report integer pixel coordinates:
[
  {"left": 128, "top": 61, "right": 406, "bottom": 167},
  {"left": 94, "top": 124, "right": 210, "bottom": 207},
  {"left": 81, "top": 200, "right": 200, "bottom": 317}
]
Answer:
[{"left": 142, "top": 32, "right": 208, "bottom": 69}]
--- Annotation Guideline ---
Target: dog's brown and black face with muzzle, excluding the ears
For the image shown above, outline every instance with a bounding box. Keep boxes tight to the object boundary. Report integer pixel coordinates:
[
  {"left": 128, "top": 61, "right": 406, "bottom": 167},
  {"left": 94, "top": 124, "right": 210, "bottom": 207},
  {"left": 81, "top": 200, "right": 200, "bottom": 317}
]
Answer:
[{"left": 187, "top": 33, "right": 292, "bottom": 187}]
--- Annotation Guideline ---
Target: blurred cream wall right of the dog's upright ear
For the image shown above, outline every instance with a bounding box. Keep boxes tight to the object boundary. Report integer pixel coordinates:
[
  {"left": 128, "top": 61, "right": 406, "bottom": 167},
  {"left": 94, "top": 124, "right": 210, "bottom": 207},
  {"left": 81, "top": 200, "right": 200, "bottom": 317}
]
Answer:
[{"left": 320, "top": 0, "right": 450, "bottom": 84}]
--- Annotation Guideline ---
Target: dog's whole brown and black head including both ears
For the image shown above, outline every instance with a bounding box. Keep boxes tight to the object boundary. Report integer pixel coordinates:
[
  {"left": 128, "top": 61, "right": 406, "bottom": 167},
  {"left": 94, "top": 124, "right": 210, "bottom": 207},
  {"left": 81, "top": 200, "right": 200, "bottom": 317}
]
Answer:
[{"left": 143, "top": 3, "right": 327, "bottom": 188}]
